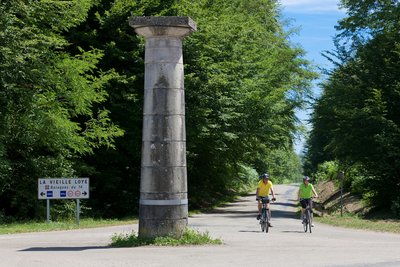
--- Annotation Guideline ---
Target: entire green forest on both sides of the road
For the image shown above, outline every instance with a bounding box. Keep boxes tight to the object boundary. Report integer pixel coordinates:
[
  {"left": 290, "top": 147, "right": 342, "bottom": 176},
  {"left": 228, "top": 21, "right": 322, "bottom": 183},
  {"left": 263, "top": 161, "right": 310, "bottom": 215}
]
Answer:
[{"left": 0, "top": 0, "right": 400, "bottom": 223}]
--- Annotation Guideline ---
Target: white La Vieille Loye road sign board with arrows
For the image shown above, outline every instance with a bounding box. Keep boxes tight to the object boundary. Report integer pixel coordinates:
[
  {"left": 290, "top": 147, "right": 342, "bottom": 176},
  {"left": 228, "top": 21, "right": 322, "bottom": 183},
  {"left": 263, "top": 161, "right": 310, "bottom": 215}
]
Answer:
[{"left": 38, "top": 178, "right": 89, "bottom": 199}]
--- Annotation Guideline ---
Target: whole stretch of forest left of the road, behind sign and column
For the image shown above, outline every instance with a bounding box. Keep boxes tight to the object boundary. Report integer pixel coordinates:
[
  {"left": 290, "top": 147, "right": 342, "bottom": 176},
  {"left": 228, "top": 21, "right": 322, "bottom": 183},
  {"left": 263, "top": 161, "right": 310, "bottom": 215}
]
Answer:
[{"left": 0, "top": 0, "right": 310, "bottom": 222}]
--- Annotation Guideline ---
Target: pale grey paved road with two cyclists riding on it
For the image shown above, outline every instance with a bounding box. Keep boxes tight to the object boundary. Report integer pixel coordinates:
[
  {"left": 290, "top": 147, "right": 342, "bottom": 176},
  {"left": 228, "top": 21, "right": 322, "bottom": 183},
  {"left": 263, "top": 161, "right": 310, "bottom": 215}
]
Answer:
[{"left": 0, "top": 185, "right": 400, "bottom": 267}]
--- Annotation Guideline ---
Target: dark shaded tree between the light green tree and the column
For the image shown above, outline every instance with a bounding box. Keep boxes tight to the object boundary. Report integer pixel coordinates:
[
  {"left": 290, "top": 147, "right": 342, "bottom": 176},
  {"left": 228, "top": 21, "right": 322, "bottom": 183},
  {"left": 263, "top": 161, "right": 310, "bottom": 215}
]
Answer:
[{"left": 65, "top": 0, "right": 180, "bottom": 217}]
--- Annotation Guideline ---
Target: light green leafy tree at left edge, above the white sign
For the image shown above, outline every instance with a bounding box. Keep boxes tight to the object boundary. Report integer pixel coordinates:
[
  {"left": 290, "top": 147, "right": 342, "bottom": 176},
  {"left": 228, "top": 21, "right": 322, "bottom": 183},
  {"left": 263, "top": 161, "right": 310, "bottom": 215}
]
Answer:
[{"left": 0, "top": 0, "right": 122, "bottom": 218}]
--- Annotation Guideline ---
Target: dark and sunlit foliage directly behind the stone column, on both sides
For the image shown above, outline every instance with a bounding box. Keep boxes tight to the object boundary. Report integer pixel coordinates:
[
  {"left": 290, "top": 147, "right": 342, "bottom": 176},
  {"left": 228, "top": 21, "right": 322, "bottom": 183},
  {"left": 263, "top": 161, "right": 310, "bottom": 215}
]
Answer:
[{"left": 61, "top": 0, "right": 315, "bottom": 216}]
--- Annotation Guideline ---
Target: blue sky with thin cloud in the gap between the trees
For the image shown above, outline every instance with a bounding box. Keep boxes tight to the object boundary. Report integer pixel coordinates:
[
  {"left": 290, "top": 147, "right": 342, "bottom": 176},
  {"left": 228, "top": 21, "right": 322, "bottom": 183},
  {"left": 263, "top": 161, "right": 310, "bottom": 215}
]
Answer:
[{"left": 280, "top": 0, "right": 346, "bottom": 154}]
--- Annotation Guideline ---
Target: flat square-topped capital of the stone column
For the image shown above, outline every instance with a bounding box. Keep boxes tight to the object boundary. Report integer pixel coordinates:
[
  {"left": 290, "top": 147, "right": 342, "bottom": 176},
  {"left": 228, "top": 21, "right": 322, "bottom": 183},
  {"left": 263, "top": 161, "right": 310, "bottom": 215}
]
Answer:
[{"left": 129, "top": 16, "right": 197, "bottom": 37}]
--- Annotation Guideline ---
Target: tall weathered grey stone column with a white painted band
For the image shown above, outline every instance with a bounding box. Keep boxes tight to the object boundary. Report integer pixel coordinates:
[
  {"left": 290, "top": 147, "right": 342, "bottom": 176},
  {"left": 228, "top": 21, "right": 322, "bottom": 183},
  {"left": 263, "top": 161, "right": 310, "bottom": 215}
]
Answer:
[{"left": 129, "top": 17, "right": 196, "bottom": 237}]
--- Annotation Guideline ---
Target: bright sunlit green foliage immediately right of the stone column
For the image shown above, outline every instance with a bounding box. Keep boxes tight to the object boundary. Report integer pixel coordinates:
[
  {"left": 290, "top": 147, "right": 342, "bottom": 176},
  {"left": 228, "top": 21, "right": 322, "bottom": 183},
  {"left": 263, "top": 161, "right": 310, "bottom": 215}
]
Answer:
[{"left": 181, "top": 1, "right": 314, "bottom": 207}]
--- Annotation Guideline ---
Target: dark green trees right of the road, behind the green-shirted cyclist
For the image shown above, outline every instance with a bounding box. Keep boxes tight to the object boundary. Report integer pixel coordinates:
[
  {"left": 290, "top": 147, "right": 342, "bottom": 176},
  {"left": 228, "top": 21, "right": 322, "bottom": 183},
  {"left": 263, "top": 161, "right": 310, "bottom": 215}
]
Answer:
[{"left": 307, "top": 0, "right": 400, "bottom": 214}]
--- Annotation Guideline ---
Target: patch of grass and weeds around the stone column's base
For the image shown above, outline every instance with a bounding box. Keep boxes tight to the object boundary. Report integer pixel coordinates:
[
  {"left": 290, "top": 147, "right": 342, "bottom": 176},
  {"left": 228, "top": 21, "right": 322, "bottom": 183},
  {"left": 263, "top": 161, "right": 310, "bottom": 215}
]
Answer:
[{"left": 110, "top": 228, "right": 222, "bottom": 247}]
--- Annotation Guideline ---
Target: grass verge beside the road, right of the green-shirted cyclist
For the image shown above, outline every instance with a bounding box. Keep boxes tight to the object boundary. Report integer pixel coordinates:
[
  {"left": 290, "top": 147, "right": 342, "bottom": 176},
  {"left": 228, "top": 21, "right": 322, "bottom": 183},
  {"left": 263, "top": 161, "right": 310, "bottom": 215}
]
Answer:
[{"left": 314, "top": 213, "right": 400, "bottom": 234}]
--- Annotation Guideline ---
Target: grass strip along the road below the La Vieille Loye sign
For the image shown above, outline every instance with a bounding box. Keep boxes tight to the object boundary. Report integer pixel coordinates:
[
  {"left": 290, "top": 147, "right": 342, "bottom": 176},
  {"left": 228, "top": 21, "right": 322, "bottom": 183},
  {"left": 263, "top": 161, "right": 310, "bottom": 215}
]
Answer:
[{"left": 0, "top": 218, "right": 138, "bottom": 234}]
